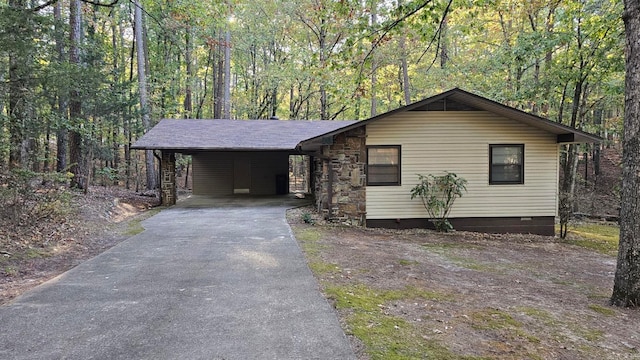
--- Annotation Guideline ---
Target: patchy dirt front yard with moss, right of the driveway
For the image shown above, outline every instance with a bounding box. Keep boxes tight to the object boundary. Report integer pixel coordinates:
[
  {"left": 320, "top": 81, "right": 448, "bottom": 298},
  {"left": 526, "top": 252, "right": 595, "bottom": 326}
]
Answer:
[{"left": 288, "top": 209, "right": 640, "bottom": 359}]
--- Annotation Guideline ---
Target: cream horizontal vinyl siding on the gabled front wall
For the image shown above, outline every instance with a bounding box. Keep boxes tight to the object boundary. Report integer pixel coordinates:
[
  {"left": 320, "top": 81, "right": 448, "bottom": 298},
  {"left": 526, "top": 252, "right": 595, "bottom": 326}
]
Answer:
[{"left": 366, "top": 111, "right": 558, "bottom": 219}]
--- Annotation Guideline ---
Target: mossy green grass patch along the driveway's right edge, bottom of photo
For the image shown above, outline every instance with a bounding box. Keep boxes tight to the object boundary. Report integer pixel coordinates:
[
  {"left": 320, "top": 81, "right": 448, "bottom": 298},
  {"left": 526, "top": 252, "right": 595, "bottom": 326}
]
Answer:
[{"left": 325, "top": 285, "right": 481, "bottom": 360}]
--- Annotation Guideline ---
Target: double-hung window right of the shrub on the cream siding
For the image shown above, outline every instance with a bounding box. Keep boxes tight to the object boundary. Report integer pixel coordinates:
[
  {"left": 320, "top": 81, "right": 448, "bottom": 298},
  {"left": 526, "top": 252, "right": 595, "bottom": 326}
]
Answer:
[{"left": 489, "top": 144, "right": 524, "bottom": 185}]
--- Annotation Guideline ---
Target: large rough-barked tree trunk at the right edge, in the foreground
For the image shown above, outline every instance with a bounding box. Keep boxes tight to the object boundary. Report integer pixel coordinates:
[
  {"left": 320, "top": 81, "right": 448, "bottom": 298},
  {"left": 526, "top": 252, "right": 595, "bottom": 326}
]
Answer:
[{"left": 611, "top": 0, "right": 640, "bottom": 307}]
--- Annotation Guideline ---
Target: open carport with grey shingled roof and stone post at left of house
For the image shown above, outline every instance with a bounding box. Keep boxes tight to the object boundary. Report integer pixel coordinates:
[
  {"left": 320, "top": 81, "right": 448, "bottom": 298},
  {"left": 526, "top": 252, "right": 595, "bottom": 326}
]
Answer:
[{"left": 132, "top": 119, "right": 353, "bottom": 205}]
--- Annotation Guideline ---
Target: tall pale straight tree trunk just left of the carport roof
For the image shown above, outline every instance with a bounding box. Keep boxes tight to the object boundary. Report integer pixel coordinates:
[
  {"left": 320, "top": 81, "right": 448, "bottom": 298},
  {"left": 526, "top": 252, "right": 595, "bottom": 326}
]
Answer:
[{"left": 134, "top": 1, "right": 157, "bottom": 190}]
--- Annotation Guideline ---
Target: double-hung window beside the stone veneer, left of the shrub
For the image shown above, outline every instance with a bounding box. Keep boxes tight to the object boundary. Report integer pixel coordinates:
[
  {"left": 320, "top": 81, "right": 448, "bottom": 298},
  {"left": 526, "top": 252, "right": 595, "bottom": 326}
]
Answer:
[{"left": 367, "top": 145, "right": 400, "bottom": 186}]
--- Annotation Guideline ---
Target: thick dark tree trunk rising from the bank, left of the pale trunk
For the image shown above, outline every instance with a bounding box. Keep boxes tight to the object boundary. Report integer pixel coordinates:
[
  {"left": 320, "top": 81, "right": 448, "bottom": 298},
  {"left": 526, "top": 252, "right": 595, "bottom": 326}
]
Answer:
[{"left": 69, "top": 0, "right": 87, "bottom": 189}]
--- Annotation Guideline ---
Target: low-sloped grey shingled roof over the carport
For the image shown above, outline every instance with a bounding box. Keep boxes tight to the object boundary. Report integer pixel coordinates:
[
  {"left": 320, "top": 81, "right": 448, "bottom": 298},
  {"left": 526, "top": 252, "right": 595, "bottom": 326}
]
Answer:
[{"left": 132, "top": 119, "right": 355, "bottom": 150}]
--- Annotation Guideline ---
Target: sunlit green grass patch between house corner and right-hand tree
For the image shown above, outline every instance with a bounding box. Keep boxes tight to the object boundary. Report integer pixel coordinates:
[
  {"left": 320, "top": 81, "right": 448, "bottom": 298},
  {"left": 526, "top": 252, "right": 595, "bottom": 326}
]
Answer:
[{"left": 567, "top": 224, "right": 620, "bottom": 255}]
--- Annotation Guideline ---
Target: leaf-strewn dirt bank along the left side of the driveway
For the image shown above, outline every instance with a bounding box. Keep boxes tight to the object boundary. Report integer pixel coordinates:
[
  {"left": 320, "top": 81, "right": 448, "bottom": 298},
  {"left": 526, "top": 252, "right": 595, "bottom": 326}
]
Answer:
[{"left": 0, "top": 186, "right": 158, "bottom": 305}]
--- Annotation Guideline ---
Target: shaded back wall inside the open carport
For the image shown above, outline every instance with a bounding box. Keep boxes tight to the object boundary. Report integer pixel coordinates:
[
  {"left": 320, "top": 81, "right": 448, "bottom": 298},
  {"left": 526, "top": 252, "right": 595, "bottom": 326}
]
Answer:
[{"left": 193, "top": 152, "right": 289, "bottom": 196}]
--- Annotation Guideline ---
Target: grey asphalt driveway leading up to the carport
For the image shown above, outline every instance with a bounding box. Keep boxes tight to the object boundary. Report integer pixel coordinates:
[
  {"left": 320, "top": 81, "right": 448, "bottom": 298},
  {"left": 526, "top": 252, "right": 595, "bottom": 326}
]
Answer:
[{"left": 0, "top": 198, "right": 355, "bottom": 359}]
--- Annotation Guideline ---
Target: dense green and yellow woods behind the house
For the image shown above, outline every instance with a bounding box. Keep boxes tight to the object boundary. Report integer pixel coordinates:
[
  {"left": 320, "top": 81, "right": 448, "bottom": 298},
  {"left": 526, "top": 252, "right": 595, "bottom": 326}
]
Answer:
[{"left": 0, "top": 0, "right": 624, "bottom": 197}]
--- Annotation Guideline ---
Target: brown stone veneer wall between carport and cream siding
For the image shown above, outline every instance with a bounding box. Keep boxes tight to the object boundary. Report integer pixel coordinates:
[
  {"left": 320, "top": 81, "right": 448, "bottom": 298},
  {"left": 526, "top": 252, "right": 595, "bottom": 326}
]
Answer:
[{"left": 314, "top": 126, "right": 367, "bottom": 225}]
